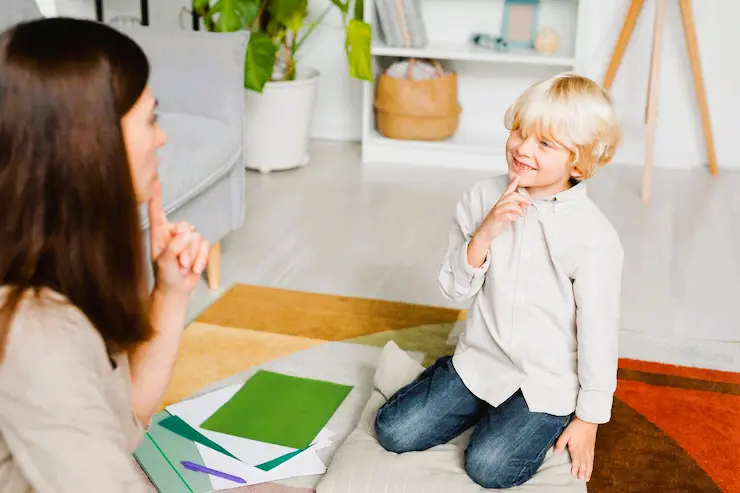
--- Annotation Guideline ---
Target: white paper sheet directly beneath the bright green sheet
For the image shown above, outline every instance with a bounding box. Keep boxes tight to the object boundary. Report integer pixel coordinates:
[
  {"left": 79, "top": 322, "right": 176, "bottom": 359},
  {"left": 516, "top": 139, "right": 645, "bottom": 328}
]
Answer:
[{"left": 166, "top": 383, "right": 334, "bottom": 468}]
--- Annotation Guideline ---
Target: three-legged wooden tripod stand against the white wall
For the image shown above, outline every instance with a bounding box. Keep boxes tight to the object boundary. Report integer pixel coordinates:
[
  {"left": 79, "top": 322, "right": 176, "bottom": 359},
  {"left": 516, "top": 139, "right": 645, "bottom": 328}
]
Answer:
[{"left": 604, "top": 0, "right": 719, "bottom": 202}]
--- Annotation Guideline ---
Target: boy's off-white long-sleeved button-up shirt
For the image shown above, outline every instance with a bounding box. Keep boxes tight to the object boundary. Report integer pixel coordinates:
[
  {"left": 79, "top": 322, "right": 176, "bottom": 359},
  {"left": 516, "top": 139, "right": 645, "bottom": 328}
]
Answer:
[{"left": 439, "top": 176, "right": 624, "bottom": 423}]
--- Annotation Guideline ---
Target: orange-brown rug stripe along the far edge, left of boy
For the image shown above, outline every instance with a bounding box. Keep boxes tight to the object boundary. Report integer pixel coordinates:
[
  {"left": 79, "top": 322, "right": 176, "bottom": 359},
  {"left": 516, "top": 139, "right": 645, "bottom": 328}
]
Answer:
[{"left": 198, "top": 284, "right": 463, "bottom": 341}]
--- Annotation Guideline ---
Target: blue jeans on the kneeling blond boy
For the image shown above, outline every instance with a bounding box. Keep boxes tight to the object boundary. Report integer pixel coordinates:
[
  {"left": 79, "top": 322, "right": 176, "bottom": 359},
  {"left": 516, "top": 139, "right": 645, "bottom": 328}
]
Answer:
[{"left": 375, "top": 356, "right": 572, "bottom": 488}]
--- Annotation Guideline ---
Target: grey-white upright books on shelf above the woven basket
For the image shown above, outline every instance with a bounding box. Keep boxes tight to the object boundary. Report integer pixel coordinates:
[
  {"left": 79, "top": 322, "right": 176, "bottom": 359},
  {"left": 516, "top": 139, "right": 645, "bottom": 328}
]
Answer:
[{"left": 375, "top": 0, "right": 428, "bottom": 48}]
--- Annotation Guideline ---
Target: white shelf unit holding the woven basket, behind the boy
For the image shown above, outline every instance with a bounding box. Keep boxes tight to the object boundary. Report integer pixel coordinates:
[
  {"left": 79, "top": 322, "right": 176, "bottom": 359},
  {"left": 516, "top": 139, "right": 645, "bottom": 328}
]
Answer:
[{"left": 362, "top": 0, "right": 588, "bottom": 172}]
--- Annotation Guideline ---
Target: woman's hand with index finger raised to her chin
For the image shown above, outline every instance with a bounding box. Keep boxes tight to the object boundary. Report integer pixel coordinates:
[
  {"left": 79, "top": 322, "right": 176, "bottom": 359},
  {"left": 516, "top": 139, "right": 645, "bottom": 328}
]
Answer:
[{"left": 149, "top": 181, "right": 210, "bottom": 296}]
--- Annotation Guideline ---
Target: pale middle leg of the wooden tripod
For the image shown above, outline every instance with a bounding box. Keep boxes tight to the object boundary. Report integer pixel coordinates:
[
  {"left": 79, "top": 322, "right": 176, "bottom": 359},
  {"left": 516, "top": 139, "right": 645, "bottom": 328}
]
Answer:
[{"left": 642, "top": 0, "right": 666, "bottom": 202}]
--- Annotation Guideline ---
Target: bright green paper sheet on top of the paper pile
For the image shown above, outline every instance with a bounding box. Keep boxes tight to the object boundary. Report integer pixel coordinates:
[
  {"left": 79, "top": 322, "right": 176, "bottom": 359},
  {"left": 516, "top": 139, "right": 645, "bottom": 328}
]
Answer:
[{"left": 200, "top": 370, "right": 352, "bottom": 449}]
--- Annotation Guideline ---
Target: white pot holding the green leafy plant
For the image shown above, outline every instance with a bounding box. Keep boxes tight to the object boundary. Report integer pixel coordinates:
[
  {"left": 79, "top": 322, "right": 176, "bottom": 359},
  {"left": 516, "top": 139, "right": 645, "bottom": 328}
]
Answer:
[{"left": 244, "top": 70, "right": 319, "bottom": 173}]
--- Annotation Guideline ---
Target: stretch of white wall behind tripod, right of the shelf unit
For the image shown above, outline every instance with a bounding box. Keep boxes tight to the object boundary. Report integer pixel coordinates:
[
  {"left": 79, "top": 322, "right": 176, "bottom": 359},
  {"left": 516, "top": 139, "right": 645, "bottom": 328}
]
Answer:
[{"left": 585, "top": 0, "right": 740, "bottom": 168}]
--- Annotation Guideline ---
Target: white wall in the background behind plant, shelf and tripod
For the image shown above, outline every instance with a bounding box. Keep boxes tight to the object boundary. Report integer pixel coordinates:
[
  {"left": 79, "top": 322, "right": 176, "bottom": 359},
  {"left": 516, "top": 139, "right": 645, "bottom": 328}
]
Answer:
[{"left": 49, "top": 0, "right": 740, "bottom": 168}]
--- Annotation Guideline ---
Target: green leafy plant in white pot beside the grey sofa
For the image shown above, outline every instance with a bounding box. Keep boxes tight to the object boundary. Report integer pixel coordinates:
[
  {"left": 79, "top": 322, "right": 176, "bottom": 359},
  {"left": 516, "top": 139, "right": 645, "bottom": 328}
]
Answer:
[{"left": 193, "top": 0, "right": 372, "bottom": 172}]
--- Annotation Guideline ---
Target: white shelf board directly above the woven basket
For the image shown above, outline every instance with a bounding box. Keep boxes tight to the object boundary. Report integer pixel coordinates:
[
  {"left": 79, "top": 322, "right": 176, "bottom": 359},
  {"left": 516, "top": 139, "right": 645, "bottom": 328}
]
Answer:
[{"left": 371, "top": 42, "right": 575, "bottom": 67}]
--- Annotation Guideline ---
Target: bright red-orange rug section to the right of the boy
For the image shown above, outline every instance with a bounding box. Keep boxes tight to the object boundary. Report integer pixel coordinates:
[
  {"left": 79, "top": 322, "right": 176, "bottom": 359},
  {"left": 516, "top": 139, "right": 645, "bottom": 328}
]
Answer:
[{"left": 615, "top": 381, "right": 740, "bottom": 493}]
